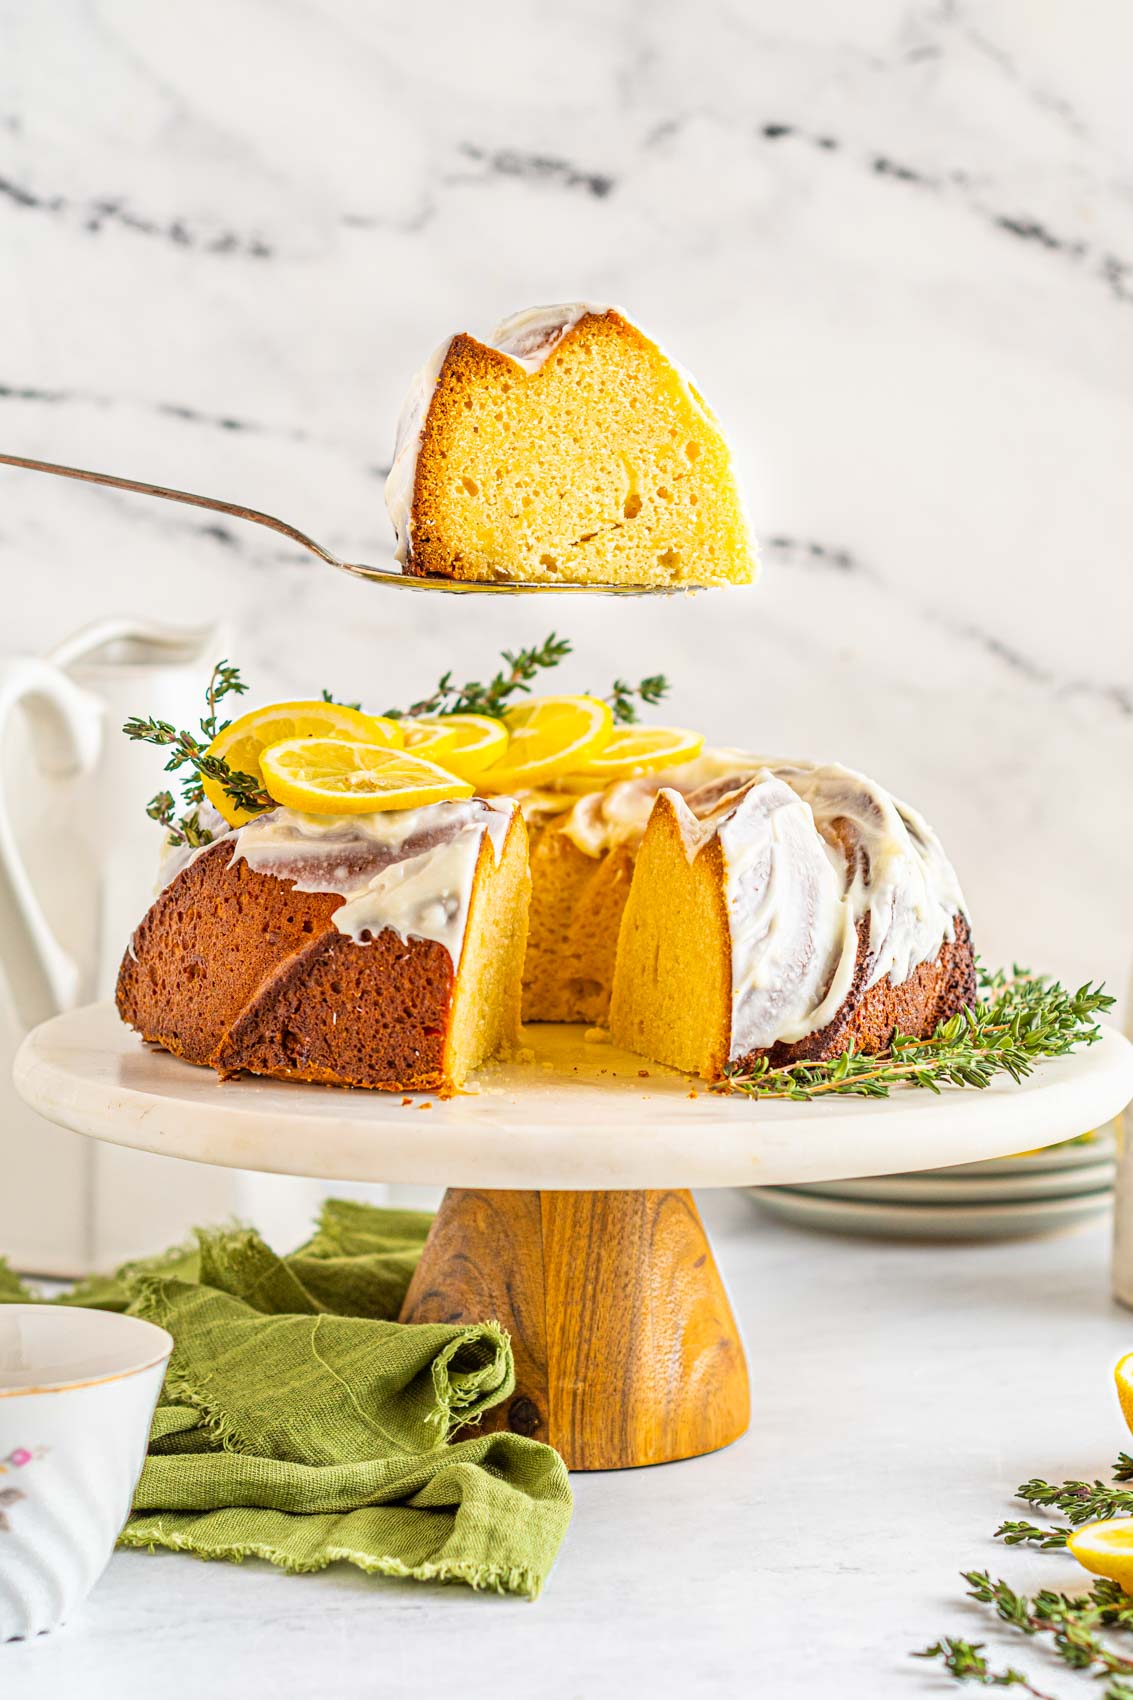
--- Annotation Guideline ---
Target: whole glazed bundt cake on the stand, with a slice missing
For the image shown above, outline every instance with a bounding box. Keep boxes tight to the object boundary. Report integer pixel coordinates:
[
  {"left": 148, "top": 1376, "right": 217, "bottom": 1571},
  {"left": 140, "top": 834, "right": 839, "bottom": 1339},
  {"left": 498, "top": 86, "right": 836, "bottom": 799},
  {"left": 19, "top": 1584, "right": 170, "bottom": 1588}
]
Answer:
[{"left": 117, "top": 750, "right": 975, "bottom": 1091}]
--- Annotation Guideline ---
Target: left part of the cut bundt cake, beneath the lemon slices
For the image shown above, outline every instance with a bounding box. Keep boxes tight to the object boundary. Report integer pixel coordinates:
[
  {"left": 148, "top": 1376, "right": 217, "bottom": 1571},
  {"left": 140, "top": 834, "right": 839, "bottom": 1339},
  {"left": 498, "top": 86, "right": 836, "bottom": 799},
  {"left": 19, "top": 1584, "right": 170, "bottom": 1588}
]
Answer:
[{"left": 117, "top": 799, "right": 529, "bottom": 1091}]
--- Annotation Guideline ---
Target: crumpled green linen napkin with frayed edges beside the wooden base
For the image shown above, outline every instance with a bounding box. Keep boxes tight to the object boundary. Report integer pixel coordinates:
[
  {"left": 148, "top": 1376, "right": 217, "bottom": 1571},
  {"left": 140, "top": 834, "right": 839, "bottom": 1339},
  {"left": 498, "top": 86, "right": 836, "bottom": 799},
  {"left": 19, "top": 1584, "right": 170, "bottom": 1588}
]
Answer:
[{"left": 0, "top": 1200, "right": 572, "bottom": 1598}]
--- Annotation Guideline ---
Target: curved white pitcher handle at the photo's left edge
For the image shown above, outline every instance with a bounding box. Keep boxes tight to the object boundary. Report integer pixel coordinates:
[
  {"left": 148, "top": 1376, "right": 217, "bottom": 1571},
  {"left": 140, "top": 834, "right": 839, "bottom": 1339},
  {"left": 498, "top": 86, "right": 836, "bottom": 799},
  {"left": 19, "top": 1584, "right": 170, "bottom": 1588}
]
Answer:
[{"left": 0, "top": 656, "right": 102, "bottom": 1027}]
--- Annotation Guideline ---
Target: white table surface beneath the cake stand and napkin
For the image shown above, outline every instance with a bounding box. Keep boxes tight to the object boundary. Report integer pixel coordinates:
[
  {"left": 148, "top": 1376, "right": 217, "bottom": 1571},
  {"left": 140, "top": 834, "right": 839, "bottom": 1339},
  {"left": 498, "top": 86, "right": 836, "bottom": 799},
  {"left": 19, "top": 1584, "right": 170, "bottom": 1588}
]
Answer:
[{"left": 0, "top": 1192, "right": 1133, "bottom": 1700}]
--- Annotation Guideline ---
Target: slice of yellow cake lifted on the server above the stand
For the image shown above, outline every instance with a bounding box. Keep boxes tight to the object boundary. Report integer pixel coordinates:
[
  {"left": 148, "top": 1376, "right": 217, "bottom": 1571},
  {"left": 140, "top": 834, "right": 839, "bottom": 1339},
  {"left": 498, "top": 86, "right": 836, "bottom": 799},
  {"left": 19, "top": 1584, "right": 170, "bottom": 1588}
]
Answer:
[{"left": 386, "top": 303, "right": 754, "bottom": 585}]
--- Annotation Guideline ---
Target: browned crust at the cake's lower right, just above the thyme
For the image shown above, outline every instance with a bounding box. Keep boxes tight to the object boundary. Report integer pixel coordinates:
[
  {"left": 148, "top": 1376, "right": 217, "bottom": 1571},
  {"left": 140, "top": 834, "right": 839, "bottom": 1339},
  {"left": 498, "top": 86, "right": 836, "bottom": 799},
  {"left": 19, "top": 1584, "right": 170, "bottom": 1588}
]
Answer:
[{"left": 735, "top": 915, "right": 976, "bottom": 1069}]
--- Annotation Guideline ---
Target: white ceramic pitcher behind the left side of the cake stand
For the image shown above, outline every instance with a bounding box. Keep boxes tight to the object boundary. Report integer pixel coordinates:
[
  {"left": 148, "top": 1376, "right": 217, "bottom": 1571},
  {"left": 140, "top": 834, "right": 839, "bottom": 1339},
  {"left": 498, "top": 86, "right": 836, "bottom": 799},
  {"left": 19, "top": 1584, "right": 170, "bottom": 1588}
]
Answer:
[{"left": 0, "top": 619, "right": 384, "bottom": 1275}]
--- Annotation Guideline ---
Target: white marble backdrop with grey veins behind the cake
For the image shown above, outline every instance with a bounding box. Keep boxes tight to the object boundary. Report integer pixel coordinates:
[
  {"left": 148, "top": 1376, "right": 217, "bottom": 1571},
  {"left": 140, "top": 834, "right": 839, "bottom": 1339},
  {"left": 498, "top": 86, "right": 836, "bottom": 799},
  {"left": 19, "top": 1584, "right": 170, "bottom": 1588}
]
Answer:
[{"left": 0, "top": 0, "right": 1133, "bottom": 986}]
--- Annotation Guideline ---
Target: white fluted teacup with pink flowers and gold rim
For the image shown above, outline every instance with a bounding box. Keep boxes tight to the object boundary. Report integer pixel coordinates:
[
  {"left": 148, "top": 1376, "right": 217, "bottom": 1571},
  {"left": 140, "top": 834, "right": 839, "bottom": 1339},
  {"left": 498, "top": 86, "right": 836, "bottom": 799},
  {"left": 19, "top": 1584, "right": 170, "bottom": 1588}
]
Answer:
[{"left": 0, "top": 1304, "right": 174, "bottom": 1641}]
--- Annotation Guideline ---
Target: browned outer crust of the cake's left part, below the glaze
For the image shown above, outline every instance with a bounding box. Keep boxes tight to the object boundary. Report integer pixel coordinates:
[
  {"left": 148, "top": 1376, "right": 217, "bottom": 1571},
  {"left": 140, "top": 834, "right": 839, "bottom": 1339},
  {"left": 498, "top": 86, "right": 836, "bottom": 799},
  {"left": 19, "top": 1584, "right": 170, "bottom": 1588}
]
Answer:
[{"left": 117, "top": 840, "right": 454, "bottom": 1090}]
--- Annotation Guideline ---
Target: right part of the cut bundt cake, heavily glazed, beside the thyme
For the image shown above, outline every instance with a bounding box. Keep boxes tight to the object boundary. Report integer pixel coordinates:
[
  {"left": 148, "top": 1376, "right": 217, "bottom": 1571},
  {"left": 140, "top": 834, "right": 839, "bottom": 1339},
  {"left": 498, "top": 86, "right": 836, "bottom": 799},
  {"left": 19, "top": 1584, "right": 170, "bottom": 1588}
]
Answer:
[{"left": 611, "top": 763, "right": 975, "bottom": 1080}]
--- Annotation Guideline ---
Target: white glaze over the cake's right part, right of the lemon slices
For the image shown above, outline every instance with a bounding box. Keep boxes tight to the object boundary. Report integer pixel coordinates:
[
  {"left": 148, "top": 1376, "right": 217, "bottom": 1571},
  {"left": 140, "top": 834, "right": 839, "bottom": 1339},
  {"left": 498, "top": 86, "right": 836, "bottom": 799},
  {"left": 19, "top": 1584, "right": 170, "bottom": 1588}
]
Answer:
[{"left": 524, "top": 748, "right": 965, "bottom": 1057}]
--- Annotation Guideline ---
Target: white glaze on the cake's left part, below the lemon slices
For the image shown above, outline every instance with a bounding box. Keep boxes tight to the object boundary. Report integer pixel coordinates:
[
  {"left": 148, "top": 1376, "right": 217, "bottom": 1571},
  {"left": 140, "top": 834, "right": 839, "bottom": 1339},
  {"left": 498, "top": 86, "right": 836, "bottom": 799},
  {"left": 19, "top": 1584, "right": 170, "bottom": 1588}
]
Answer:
[{"left": 163, "top": 797, "right": 515, "bottom": 966}]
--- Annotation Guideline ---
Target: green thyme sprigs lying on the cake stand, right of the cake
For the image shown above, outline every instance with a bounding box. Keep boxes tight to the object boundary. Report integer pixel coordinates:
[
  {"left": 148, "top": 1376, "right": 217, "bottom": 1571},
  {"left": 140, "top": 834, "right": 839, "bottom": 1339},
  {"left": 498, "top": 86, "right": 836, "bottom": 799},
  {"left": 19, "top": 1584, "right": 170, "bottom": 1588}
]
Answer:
[{"left": 713, "top": 967, "right": 1116, "bottom": 1100}]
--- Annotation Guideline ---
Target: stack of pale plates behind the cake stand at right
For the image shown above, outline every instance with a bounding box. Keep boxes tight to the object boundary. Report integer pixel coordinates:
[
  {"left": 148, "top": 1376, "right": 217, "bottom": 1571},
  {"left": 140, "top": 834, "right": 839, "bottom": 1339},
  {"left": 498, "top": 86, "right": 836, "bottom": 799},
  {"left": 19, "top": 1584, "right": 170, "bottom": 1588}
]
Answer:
[{"left": 747, "top": 1129, "right": 1116, "bottom": 1239}]
